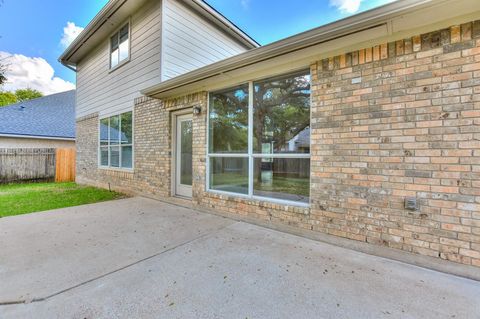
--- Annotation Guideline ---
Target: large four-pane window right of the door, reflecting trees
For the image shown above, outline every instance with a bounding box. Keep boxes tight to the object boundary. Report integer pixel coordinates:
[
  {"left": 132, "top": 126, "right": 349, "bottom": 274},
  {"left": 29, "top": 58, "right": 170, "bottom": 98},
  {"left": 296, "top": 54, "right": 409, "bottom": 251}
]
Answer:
[{"left": 208, "top": 71, "right": 310, "bottom": 204}]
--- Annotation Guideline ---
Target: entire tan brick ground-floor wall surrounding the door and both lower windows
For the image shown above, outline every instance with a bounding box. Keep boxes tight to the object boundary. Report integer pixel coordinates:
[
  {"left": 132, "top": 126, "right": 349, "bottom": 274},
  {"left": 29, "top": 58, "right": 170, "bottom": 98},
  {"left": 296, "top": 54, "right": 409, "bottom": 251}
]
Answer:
[{"left": 77, "top": 22, "right": 480, "bottom": 267}]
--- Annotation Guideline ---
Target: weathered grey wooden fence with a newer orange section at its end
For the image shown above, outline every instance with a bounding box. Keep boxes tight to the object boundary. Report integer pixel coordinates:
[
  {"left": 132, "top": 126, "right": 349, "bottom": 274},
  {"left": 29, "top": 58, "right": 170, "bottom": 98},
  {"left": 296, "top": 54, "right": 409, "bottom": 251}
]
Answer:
[{"left": 0, "top": 148, "right": 75, "bottom": 184}]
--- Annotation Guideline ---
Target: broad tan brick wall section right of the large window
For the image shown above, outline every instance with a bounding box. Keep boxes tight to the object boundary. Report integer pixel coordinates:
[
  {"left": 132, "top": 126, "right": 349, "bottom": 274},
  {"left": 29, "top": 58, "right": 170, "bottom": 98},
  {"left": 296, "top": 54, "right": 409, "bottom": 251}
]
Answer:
[{"left": 310, "top": 21, "right": 480, "bottom": 266}]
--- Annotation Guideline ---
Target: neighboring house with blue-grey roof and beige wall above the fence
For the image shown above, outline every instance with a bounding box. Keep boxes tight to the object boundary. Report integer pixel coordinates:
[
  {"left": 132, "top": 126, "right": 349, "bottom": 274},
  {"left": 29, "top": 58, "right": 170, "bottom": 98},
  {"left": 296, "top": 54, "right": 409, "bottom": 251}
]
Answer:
[{"left": 0, "top": 90, "right": 75, "bottom": 148}]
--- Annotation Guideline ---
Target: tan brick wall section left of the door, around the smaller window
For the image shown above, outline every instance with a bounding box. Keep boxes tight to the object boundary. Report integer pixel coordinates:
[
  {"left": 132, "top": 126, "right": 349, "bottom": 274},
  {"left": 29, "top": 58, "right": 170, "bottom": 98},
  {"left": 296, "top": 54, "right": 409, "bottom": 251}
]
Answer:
[{"left": 76, "top": 97, "right": 171, "bottom": 197}]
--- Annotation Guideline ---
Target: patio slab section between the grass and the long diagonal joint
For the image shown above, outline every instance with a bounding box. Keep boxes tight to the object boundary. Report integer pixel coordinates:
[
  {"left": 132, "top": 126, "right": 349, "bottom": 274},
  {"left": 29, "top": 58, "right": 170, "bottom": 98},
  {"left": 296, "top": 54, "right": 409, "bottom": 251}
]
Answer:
[{"left": 0, "top": 198, "right": 233, "bottom": 303}]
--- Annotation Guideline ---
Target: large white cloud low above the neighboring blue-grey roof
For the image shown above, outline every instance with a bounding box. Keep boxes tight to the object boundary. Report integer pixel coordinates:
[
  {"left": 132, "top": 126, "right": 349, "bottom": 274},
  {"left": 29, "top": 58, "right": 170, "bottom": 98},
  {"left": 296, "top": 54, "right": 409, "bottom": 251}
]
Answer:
[{"left": 0, "top": 51, "right": 75, "bottom": 95}]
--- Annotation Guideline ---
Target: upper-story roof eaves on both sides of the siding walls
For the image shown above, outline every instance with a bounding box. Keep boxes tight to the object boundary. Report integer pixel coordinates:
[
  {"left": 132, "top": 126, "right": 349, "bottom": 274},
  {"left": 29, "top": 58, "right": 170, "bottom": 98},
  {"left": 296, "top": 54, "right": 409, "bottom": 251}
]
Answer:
[{"left": 59, "top": 0, "right": 260, "bottom": 67}]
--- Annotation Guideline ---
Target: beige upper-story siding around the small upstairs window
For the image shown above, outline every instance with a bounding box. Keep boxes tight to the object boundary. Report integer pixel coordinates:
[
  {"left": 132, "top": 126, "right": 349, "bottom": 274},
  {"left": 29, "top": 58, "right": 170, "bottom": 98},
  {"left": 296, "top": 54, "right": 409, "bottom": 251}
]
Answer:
[{"left": 77, "top": 0, "right": 161, "bottom": 118}]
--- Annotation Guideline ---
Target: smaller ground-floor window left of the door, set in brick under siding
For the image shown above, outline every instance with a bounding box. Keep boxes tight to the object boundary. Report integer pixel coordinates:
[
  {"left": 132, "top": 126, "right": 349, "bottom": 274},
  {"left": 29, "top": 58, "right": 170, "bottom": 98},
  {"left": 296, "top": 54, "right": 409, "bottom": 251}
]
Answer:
[{"left": 99, "top": 112, "right": 133, "bottom": 168}]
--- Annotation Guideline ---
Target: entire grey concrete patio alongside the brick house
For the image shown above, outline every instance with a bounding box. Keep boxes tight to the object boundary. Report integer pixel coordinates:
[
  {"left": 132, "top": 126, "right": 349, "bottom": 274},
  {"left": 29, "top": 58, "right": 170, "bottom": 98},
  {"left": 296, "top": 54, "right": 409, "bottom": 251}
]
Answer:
[{"left": 0, "top": 198, "right": 480, "bottom": 319}]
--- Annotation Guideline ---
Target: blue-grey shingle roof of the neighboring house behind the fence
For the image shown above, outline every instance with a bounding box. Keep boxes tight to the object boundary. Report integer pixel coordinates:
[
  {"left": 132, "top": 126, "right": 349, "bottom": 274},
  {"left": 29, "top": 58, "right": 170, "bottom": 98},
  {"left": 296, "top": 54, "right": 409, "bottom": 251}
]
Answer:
[{"left": 0, "top": 90, "right": 75, "bottom": 139}]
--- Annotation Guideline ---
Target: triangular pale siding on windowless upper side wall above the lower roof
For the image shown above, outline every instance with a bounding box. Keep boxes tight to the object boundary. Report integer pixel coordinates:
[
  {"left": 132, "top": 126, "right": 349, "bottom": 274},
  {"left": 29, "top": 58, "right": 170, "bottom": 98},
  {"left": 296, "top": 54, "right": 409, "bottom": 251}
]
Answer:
[{"left": 162, "top": 0, "right": 247, "bottom": 80}]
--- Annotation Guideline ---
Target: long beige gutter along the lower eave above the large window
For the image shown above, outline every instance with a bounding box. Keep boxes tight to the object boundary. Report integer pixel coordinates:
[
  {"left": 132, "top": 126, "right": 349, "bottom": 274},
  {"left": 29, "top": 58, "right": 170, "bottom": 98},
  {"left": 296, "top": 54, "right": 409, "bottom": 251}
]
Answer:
[{"left": 141, "top": 0, "right": 438, "bottom": 96}]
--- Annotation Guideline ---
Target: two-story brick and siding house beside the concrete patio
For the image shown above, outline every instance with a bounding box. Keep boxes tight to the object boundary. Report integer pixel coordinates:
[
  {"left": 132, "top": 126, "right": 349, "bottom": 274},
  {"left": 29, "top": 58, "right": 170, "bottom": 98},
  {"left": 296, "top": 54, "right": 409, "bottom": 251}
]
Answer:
[{"left": 60, "top": 0, "right": 480, "bottom": 271}]
